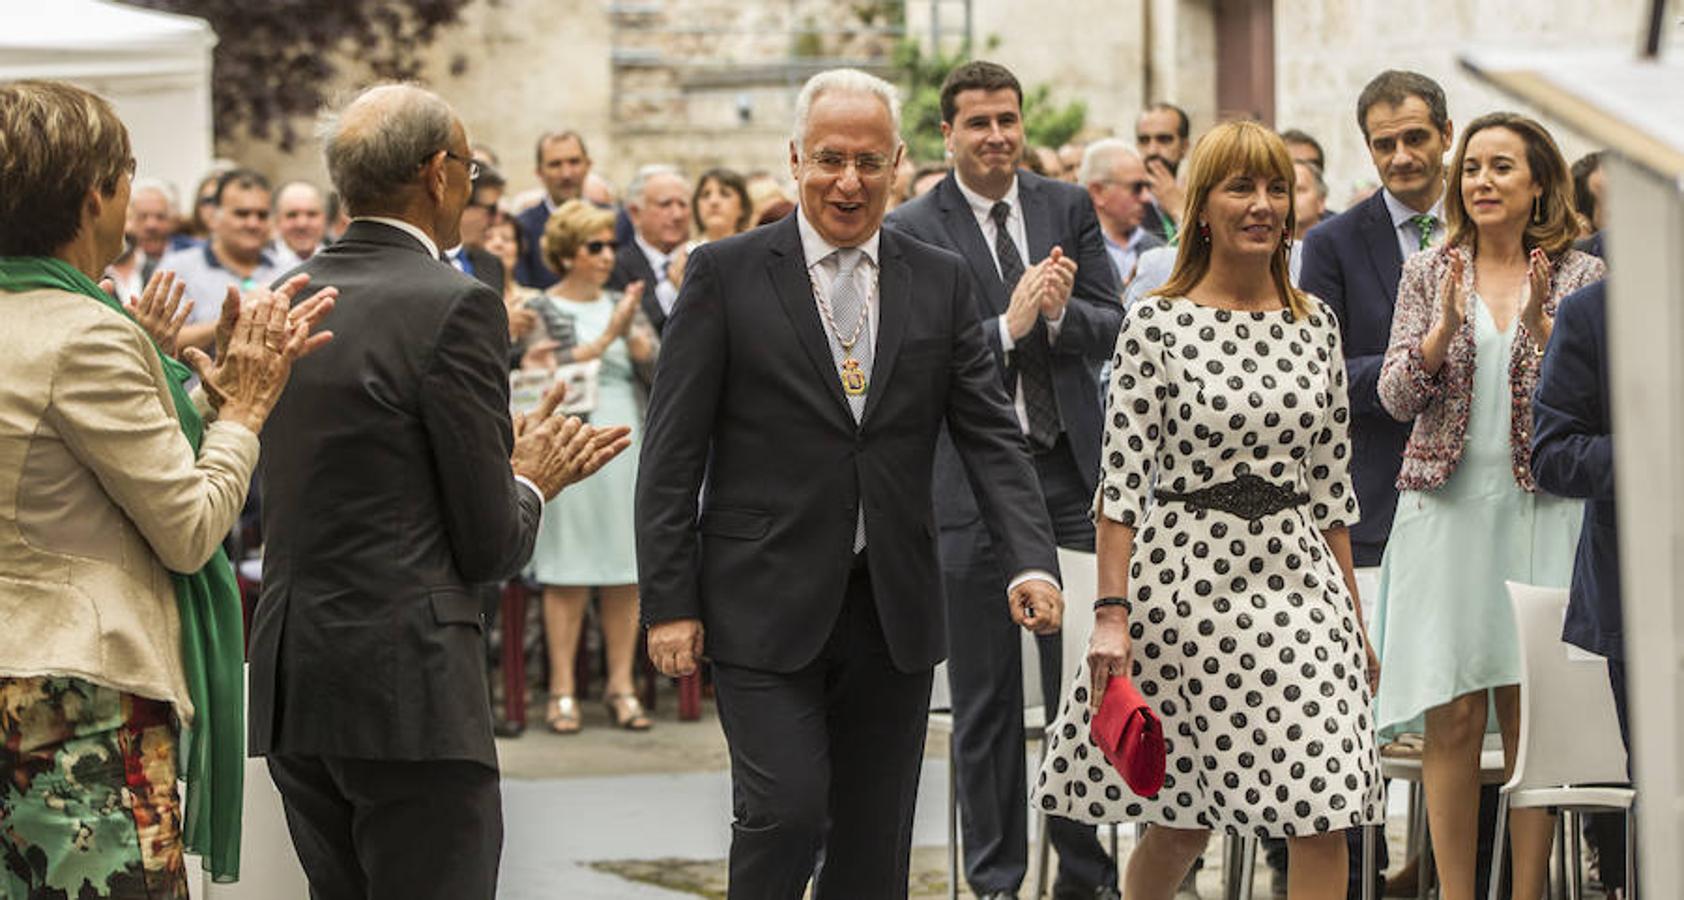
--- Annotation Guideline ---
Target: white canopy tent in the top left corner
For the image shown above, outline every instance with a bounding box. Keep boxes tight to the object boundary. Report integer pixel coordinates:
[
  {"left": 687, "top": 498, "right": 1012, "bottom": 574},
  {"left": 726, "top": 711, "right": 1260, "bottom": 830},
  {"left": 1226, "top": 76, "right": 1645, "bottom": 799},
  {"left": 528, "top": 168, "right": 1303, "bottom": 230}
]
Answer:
[{"left": 0, "top": 0, "right": 217, "bottom": 217}]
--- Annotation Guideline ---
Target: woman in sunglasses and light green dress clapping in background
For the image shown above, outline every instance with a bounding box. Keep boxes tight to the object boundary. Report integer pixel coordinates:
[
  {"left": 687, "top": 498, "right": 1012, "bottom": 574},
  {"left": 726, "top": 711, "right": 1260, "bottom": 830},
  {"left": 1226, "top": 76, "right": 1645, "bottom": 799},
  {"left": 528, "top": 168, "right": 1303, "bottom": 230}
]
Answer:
[{"left": 529, "top": 201, "right": 657, "bottom": 735}]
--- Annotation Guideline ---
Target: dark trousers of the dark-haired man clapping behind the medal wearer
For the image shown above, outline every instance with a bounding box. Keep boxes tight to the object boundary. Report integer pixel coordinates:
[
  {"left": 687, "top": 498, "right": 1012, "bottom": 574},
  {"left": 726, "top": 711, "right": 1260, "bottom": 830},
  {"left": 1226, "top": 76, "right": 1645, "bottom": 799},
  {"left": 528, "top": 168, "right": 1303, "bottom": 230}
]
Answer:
[{"left": 941, "top": 437, "right": 1116, "bottom": 893}]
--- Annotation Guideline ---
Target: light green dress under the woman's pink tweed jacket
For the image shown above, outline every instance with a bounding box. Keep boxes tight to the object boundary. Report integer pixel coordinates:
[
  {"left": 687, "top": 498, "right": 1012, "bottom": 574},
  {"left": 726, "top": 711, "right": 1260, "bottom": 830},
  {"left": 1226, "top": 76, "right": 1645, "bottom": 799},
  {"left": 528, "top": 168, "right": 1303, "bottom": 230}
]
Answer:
[{"left": 1374, "top": 295, "right": 1583, "bottom": 740}]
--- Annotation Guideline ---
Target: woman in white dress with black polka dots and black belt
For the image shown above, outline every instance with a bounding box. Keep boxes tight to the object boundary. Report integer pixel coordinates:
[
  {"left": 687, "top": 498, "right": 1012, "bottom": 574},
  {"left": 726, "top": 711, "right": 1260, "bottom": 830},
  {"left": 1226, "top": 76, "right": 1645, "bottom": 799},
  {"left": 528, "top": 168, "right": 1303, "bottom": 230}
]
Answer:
[{"left": 1034, "top": 123, "right": 1383, "bottom": 900}]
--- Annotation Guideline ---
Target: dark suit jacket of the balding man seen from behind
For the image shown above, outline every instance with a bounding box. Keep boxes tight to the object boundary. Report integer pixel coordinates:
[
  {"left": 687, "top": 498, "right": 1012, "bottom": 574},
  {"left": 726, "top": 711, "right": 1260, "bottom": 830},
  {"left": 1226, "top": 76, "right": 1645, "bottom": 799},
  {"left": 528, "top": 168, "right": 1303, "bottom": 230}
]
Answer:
[{"left": 249, "top": 221, "right": 542, "bottom": 767}]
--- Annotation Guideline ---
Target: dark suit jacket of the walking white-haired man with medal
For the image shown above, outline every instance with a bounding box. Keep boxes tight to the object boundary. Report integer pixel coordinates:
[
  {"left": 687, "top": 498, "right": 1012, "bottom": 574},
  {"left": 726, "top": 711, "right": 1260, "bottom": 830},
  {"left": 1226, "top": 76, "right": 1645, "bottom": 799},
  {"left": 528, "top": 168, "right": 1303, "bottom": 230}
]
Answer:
[{"left": 637, "top": 217, "right": 1058, "bottom": 672}]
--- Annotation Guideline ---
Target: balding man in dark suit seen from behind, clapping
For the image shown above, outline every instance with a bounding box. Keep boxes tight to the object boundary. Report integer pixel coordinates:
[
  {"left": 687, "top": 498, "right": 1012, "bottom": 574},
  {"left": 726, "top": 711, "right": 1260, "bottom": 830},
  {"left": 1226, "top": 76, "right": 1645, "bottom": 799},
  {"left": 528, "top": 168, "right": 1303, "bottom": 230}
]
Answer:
[{"left": 249, "top": 86, "right": 628, "bottom": 900}]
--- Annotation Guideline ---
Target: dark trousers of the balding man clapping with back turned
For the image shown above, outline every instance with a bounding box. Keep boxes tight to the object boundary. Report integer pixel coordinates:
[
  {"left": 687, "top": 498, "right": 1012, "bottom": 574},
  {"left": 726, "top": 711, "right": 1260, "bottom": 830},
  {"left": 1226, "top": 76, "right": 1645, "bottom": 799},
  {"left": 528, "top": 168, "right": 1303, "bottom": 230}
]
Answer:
[{"left": 268, "top": 755, "right": 504, "bottom": 900}]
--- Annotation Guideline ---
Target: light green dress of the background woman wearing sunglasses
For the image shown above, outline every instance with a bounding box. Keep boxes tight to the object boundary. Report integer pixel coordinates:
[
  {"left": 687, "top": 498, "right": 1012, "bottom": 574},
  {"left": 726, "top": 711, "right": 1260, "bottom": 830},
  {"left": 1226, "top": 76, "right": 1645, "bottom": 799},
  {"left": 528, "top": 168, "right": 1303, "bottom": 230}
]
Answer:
[{"left": 532, "top": 293, "right": 643, "bottom": 587}]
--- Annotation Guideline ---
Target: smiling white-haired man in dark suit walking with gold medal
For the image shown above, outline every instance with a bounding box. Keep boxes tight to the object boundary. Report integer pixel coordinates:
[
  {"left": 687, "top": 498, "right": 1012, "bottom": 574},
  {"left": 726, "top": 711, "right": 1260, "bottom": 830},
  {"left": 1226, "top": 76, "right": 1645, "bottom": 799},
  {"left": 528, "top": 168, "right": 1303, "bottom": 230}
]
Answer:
[{"left": 637, "top": 69, "right": 1063, "bottom": 900}]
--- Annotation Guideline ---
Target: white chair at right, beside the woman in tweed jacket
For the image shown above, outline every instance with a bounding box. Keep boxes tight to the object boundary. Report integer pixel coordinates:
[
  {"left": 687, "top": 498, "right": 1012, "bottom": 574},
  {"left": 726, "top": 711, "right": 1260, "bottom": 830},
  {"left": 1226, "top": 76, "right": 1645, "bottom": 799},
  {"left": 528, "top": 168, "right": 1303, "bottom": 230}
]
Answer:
[{"left": 1490, "top": 581, "right": 1637, "bottom": 900}]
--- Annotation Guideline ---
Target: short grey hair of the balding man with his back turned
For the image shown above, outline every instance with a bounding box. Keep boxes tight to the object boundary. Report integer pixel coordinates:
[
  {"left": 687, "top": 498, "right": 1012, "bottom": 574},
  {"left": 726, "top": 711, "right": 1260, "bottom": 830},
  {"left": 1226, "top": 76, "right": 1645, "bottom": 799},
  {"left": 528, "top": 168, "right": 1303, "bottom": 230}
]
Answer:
[{"left": 317, "top": 84, "right": 456, "bottom": 216}]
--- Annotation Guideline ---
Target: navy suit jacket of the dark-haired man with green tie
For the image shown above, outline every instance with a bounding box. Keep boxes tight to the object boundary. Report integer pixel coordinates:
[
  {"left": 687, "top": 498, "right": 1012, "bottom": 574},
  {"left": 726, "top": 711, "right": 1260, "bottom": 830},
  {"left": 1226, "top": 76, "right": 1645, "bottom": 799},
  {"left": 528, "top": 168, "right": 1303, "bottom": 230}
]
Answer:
[{"left": 1298, "top": 190, "right": 1410, "bottom": 566}]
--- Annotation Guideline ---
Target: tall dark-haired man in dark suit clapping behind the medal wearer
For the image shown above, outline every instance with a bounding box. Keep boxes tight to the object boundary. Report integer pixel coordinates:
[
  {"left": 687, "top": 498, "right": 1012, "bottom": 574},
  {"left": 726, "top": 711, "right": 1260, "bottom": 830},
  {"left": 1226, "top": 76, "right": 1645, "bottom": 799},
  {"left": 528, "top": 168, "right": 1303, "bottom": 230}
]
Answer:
[{"left": 889, "top": 61, "right": 1123, "bottom": 900}]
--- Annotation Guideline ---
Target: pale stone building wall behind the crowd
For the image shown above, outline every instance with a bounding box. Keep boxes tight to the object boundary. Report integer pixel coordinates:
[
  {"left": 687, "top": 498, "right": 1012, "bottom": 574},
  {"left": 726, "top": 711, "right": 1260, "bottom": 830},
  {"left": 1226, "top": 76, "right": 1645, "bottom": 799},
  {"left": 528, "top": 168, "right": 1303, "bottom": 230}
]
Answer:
[{"left": 219, "top": 0, "right": 1670, "bottom": 206}]
